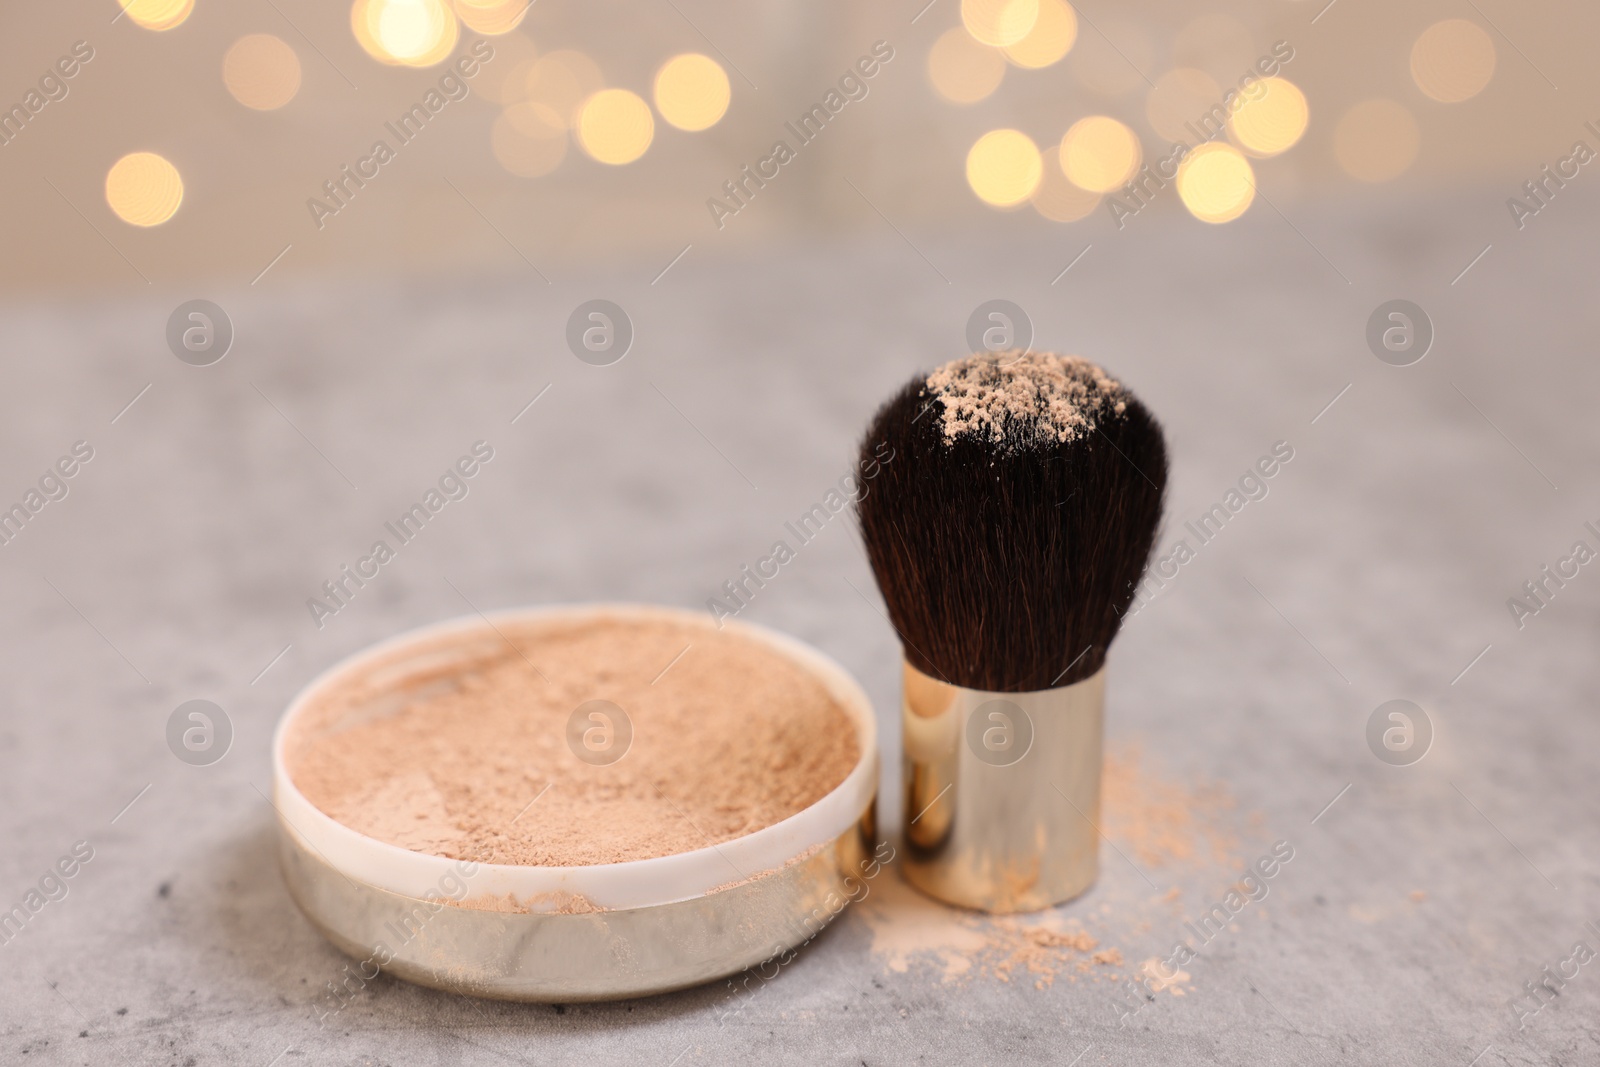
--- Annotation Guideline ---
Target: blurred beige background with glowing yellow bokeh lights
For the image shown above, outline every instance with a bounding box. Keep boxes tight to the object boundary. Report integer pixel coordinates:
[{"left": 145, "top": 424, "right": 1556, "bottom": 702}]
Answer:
[{"left": 0, "top": 0, "right": 1600, "bottom": 291}]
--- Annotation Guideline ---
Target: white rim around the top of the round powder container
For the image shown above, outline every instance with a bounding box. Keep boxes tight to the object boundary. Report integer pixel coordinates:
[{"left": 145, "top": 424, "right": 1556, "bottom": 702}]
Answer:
[{"left": 272, "top": 603, "right": 878, "bottom": 915}]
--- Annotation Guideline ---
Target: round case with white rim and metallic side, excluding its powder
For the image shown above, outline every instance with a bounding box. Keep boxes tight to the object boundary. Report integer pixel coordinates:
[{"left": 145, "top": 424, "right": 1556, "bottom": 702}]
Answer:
[{"left": 272, "top": 605, "right": 886, "bottom": 1003}]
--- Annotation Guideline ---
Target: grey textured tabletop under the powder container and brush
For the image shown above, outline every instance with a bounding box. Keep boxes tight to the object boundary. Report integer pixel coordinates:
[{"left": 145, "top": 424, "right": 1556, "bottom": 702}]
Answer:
[{"left": 0, "top": 190, "right": 1600, "bottom": 1067}]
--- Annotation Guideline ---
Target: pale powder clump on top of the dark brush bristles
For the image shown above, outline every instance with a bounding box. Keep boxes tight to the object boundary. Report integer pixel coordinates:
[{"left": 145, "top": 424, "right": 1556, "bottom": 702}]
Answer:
[{"left": 926, "top": 350, "right": 1128, "bottom": 445}]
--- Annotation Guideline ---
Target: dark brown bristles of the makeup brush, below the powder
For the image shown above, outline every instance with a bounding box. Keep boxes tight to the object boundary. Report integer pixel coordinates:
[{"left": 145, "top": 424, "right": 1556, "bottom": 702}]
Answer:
[{"left": 856, "top": 358, "right": 1166, "bottom": 693}]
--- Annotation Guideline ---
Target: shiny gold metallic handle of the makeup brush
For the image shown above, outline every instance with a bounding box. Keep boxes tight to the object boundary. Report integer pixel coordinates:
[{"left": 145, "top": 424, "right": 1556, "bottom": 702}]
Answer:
[{"left": 901, "top": 664, "right": 1106, "bottom": 912}]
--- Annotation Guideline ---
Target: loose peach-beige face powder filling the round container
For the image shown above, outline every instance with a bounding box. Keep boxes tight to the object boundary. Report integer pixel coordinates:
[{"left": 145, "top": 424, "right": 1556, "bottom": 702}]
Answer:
[{"left": 286, "top": 617, "right": 859, "bottom": 867}]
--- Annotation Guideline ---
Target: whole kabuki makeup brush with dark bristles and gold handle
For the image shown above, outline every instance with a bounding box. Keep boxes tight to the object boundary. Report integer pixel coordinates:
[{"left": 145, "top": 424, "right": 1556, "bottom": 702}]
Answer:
[{"left": 856, "top": 352, "right": 1166, "bottom": 912}]
